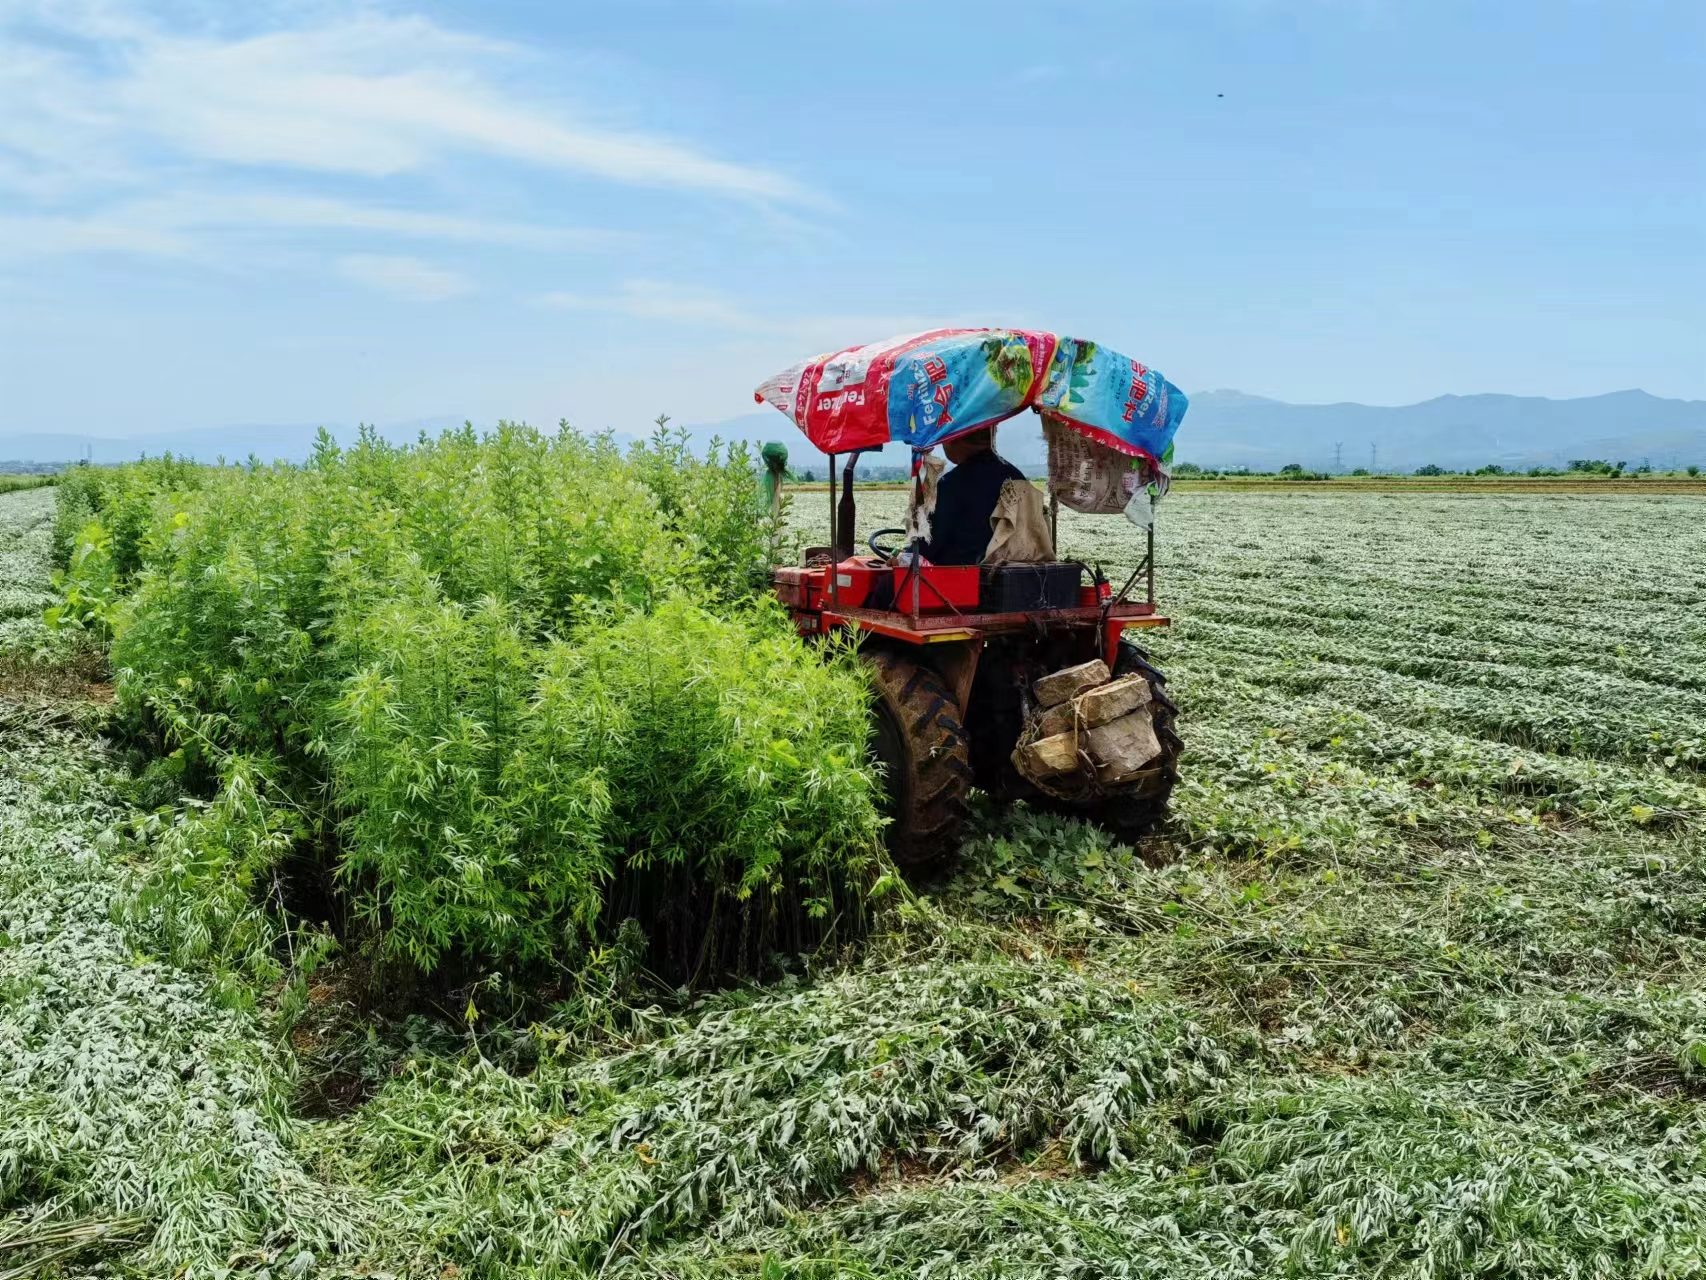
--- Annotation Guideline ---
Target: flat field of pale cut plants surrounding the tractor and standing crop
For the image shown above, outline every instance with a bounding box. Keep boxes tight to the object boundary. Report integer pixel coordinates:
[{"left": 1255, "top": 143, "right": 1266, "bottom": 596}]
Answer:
[{"left": 0, "top": 474, "right": 1706, "bottom": 1280}]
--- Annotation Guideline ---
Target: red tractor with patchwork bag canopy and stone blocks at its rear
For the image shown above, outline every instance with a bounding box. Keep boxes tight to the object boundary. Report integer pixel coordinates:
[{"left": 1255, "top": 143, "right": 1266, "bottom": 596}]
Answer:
[{"left": 759, "top": 329, "right": 1184, "bottom": 869}]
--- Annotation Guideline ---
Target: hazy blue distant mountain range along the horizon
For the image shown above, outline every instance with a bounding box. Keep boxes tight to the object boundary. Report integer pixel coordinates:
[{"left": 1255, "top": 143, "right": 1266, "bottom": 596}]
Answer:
[{"left": 0, "top": 391, "right": 1706, "bottom": 471}]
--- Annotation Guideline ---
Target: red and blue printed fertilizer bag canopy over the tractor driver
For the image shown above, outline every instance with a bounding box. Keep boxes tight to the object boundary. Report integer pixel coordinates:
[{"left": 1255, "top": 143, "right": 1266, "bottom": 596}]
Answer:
[{"left": 754, "top": 329, "right": 1189, "bottom": 466}]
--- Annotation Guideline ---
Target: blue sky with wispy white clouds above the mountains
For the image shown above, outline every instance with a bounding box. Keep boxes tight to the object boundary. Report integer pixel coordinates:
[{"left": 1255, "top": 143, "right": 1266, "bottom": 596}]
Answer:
[{"left": 0, "top": 0, "right": 1706, "bottom": 437}]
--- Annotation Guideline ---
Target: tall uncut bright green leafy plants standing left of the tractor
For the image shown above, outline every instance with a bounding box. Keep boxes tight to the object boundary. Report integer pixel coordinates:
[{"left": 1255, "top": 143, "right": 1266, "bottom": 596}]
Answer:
[{"left": 55, "top": 425, "right": 877, "bottom": 978}]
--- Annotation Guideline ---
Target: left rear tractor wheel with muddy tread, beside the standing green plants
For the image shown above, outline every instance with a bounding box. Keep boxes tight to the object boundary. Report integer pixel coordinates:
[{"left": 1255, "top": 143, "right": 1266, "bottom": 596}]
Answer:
[{"left": 865, "top": 650, "right": 971, "bottom": 870}]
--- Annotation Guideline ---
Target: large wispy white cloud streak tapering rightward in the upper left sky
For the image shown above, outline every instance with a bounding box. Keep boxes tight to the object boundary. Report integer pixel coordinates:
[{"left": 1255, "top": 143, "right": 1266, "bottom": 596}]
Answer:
[{"left": 0, "top": 5, "right": 812, "bottom": 203}]
